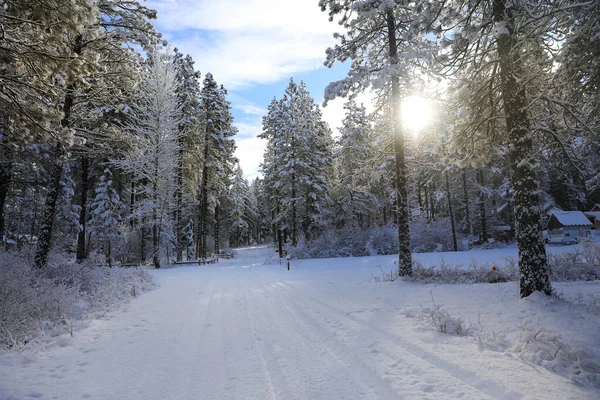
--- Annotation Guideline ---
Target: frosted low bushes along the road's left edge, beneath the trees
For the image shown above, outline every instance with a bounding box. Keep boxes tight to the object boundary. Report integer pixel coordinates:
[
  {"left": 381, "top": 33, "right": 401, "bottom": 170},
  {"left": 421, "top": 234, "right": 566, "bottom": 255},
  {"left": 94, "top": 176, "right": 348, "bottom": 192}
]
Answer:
[{"left": 0, "top": 253, "right": 155, "bottom": 351}]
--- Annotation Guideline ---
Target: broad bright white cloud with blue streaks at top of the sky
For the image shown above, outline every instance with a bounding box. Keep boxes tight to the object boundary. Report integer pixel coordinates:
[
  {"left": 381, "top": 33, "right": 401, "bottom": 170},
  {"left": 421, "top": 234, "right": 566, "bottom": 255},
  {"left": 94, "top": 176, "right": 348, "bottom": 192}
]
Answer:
[{"left": 148, "top": 0, "right": 338, "bottom": 89}]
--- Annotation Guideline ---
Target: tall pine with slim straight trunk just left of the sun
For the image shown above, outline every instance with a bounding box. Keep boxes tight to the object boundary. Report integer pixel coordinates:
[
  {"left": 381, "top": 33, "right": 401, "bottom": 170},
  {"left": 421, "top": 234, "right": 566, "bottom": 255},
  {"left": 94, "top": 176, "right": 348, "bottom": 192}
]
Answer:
[{"left": 319, "top": 0, "right": 425, "bottom": 276}]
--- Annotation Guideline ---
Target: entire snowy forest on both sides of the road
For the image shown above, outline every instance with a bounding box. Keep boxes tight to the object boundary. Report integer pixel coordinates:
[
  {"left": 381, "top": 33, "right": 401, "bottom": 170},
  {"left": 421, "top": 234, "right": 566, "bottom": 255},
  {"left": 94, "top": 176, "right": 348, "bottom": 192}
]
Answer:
[{"left": 0, "top": 0, "right": 600, "bottom": 344}]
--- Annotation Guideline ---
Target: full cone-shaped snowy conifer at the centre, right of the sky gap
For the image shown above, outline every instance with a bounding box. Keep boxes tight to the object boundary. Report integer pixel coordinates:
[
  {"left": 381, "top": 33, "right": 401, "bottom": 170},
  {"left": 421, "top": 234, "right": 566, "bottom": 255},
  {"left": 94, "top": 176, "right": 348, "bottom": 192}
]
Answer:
[{"left": 261, "top": 80, "right": 333, "bottom": 250}]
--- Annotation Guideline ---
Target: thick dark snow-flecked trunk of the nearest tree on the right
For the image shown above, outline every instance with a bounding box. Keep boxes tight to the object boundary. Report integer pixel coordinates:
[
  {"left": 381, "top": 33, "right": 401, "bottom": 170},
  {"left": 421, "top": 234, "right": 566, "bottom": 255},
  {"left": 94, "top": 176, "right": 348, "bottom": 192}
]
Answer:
[{"left": 494, "top": 0, "right": 552, "bottom": 298}]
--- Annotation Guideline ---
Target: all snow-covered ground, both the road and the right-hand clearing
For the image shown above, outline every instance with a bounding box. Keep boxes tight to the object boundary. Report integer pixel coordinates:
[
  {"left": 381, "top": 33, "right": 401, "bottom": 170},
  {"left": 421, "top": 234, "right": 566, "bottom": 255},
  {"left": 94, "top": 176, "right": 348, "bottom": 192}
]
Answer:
[{"left": 0, "top": 246, "right": 600, "bottom": 400}]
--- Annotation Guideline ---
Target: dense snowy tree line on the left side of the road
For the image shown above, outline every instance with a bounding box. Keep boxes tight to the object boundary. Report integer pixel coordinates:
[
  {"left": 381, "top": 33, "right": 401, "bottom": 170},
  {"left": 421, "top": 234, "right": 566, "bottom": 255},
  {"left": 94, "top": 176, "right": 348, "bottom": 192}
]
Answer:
[{"left": 0, "top": 0, "right": 246, "bottom": 268}]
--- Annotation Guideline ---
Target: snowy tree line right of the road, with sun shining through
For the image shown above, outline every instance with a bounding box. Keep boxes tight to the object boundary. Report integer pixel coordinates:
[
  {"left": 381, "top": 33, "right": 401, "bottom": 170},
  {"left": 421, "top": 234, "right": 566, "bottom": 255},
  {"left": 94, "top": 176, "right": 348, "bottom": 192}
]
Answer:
[{"left": 263, "top": 0, "right": 600, "bottom": 297}]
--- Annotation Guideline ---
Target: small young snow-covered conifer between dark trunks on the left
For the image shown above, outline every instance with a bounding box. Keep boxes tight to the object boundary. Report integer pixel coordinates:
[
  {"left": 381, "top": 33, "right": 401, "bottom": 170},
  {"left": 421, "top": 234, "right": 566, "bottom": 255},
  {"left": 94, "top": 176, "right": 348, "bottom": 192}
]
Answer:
[{"left": 90, "top": 168, "right": 125, "bottom": 266}]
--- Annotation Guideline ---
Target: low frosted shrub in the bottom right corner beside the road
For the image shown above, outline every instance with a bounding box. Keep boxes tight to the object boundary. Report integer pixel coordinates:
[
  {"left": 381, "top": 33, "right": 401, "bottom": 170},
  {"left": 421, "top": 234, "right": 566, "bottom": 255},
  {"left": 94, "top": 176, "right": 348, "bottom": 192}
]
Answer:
[{"left": 512, "top": 321, "right": 600, "bottom": 388}]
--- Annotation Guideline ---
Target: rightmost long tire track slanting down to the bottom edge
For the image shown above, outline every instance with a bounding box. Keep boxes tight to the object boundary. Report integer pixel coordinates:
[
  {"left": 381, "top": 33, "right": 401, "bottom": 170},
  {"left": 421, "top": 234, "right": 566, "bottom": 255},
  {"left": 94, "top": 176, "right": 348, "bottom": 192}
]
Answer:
[{"left": 270, "top": 281, "right": 523, "bottom": 399}]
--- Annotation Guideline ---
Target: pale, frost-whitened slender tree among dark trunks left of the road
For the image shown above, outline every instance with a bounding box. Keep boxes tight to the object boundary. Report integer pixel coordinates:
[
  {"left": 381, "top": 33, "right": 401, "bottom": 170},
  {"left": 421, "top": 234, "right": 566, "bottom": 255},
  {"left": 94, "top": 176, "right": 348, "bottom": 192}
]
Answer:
[{"left": 113, "top": 51, "right": 181, "bottom": 268}]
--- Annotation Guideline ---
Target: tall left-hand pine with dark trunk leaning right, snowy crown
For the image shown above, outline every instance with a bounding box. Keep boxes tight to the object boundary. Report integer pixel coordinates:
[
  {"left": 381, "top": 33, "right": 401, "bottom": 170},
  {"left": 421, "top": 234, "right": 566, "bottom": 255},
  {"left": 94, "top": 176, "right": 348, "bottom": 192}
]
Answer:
[{"left": 35, "top": 0, "right": 158, "bottom": 268}]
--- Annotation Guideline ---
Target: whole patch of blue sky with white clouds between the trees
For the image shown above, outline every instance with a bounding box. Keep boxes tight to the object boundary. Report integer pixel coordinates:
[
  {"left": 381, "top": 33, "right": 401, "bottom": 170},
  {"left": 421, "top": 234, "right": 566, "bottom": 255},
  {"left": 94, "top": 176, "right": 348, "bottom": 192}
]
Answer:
[{"left": 146, "top": 0, "right": 347, "bottom": 179}]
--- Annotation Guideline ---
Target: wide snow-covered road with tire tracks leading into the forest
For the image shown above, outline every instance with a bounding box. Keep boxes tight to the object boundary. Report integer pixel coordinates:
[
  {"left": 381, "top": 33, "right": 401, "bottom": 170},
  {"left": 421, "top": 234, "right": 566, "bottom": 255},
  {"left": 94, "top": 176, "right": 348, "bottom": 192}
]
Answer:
[{"left": 0, "top": 247, "right": 597, "bottom": 400}]
